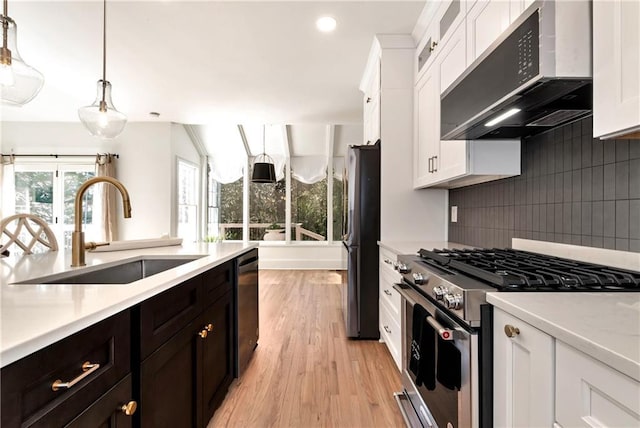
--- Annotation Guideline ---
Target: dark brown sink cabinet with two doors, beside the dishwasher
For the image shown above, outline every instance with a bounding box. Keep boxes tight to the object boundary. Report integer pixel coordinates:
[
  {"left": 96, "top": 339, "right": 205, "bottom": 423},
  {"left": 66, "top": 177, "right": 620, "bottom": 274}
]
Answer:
[{"left": 140, "top": 262, "right": 235, "bottom": 428}]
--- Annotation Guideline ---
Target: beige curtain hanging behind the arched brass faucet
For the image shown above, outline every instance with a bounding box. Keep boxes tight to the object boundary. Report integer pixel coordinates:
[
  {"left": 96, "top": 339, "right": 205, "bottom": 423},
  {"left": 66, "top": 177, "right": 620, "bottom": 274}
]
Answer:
[{"left": 95, "top": 154, "right": 118, "bottom": 242}]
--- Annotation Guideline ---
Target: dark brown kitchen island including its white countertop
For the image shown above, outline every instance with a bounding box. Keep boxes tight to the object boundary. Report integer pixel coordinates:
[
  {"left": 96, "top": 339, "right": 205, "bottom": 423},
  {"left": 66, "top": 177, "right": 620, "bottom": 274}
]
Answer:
[{"left": 0, "top": 243, "right": 258, "bottom": 428}]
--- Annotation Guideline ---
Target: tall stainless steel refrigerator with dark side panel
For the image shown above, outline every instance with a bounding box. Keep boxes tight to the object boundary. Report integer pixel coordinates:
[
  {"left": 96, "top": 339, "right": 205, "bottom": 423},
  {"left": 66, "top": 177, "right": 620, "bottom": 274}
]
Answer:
[{"left": 342, "top": 140, "right": 380, "bottom": 339}]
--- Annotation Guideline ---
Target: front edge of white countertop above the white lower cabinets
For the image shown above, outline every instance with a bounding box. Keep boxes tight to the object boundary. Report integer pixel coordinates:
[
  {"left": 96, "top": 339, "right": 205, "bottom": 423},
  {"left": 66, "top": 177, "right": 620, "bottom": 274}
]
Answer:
[{"left": 487, "top": 293, "right": 640, "bottom": 381}]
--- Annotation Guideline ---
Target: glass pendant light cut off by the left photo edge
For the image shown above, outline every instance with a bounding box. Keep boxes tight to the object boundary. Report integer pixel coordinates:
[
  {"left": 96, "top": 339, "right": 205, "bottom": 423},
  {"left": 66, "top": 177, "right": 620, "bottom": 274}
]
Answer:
[{"left": 0, "top": 0, "right": 44, "bottom": 107}]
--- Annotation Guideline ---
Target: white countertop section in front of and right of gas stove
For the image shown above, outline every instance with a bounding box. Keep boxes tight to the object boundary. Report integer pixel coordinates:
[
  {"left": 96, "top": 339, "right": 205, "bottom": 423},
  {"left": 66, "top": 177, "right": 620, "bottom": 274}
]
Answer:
[{"left": 487, "top": 292, "right": 640, "bottom": 381}]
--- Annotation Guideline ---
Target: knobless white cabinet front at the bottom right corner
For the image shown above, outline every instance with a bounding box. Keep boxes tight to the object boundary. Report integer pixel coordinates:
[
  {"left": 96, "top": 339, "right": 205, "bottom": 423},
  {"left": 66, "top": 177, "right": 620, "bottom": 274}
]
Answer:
[{"left": 556, "top": 341, "right": 640, "bottom": 428}]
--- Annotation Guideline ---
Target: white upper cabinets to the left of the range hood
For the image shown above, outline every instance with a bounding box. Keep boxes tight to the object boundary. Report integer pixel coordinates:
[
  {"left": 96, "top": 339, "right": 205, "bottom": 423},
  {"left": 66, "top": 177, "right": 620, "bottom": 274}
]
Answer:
[{"left": 413, "top": 0, "right": 520, "bottom": 188}]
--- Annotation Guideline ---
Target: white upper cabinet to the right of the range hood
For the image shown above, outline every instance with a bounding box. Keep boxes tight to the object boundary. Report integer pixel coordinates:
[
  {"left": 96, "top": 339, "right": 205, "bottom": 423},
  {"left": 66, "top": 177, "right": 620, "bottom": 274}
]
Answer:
[{"left": 593, "top": 0, "right": 640, "bottom": 138}]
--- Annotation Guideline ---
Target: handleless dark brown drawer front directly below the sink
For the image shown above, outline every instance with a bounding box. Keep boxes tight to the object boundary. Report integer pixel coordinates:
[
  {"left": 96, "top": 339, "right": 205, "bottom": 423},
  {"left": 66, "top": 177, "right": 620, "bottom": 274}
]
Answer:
[{"left": 140, "top": 275, "right": 203, "bottom": 361}]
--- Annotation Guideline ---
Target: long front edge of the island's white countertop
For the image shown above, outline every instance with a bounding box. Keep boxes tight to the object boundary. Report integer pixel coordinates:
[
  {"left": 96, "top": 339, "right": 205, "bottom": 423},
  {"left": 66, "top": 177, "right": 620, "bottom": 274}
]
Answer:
[{"left": 0, "top": 244, "right": 258, "bottom": 368}]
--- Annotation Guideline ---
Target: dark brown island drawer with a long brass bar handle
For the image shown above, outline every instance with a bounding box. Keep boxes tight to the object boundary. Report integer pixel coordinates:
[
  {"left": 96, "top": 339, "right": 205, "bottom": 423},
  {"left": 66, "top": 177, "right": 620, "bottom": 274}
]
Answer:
[{"left": 0, "top": 310, "right": 131, "bottom": 428}]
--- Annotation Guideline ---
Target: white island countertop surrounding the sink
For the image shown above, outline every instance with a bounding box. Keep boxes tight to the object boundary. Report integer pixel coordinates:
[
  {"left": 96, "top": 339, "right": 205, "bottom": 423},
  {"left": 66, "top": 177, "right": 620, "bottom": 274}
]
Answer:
[{"left": 0, "top": 243, "right": 257, "bottom": 367}]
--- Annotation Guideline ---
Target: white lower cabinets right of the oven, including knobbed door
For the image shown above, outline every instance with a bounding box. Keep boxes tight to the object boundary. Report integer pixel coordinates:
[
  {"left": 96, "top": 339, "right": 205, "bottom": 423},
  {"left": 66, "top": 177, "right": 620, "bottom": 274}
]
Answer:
[{"left": 493, "top": 307, "right": 640, "bottom": 428}]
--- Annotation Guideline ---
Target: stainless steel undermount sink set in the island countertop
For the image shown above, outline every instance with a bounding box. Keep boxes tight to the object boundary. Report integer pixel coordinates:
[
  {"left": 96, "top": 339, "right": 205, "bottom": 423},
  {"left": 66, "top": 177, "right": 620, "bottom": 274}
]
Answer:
[{"left": 17, "top": 256, "right": 204, "bottom": 284}]
